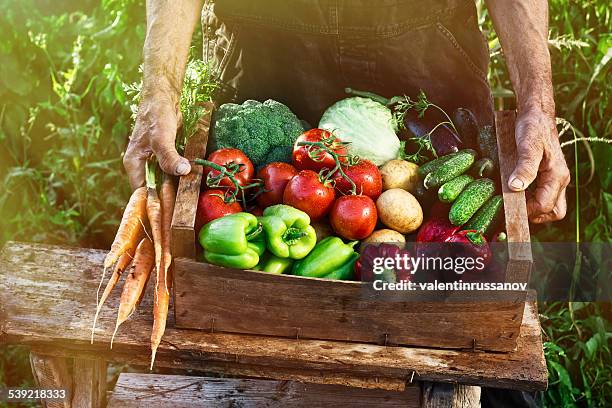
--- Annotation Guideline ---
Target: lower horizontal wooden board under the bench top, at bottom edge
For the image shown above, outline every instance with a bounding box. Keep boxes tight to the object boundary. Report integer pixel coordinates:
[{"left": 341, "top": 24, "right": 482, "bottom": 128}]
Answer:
[{"left": 108, "top": 374, "right": 420, "bottom": 408}]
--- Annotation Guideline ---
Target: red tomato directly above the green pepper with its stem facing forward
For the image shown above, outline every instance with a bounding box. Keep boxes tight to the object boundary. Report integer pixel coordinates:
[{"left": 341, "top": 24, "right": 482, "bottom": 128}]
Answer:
[{"left": 283, "top": 170, "right": 336, "bottom": 221}]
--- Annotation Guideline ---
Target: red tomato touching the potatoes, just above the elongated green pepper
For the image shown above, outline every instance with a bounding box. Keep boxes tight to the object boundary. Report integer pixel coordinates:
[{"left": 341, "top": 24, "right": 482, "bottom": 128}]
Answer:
[{"left": 329, "top": 195, "right": 378, "bottom": 240}]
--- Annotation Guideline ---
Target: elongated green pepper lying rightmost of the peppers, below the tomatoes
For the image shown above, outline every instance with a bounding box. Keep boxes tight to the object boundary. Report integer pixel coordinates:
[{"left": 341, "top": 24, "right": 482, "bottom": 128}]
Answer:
[{"left": 293, "top": 237, "right": 357, "bottom": 278}]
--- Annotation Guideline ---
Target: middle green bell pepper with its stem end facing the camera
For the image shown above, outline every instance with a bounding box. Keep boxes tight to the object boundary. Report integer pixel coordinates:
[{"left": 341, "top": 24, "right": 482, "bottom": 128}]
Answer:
[{"left": 259, "top": 204, "right": 317, "bottom": 259}]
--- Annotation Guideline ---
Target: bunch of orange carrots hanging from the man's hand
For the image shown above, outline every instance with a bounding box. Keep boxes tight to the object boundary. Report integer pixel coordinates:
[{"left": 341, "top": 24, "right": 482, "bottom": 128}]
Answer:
[{"left": 91, "top": 159, "right": 176, "bottom": 369}]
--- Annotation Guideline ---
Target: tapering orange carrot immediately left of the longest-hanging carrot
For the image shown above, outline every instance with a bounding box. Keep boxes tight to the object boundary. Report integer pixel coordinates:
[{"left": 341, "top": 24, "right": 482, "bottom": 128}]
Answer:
[{"left": 111, "top": 237, "right": 155, "bottom": 348}]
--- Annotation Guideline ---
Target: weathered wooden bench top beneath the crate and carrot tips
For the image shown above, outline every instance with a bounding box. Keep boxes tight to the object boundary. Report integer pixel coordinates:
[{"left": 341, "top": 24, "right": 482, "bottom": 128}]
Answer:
[{"left": 0, "top": 243, "right": 547, "bottom": 390}]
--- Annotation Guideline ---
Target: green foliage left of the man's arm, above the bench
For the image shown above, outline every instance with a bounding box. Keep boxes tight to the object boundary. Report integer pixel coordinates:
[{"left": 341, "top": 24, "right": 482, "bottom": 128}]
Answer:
[{"left": 0, "top": 0, "right": 144, "bottom": 246}]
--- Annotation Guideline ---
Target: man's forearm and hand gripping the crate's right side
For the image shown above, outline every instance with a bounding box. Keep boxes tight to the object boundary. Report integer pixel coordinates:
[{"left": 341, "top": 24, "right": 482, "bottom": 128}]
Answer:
[{"left": 486, "top": 0, "right": 570, "bottom": 223}]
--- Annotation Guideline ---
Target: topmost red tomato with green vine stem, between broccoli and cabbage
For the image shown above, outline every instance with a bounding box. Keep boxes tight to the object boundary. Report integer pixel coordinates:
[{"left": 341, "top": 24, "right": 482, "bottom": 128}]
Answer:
[{"left": 293, "top": 129, "right": 346, "bottom": 172}]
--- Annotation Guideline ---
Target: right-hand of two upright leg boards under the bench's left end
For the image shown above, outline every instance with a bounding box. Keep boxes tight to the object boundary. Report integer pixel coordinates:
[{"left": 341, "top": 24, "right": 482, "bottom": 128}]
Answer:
[{"left": 72, "top": 357, "right": 106, "bottom": 408}]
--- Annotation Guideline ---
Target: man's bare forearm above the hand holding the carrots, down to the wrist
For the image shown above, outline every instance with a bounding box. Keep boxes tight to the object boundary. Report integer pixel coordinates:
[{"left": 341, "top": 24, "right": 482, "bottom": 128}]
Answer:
[{"left": 142, "top": 0, "right": 203, "bottom": 108}]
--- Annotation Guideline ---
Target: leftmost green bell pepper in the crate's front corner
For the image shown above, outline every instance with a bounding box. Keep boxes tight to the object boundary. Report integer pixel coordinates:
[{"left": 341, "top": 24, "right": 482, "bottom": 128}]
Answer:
[{"left": 199, "top": 212, "right": 266, "bottom": 269}]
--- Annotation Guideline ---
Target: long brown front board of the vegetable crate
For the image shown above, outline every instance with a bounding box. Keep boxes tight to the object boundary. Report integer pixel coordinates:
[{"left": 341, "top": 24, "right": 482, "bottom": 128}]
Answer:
[{"left": 174, "top": 258, "right": 525, "bottom": 351}]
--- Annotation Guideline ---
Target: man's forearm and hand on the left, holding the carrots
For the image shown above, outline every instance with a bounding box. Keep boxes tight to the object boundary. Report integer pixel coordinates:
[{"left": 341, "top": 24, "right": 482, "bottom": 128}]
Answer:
[{"left": 123, "top": 0, "right": 203, "bottom": 189}]
